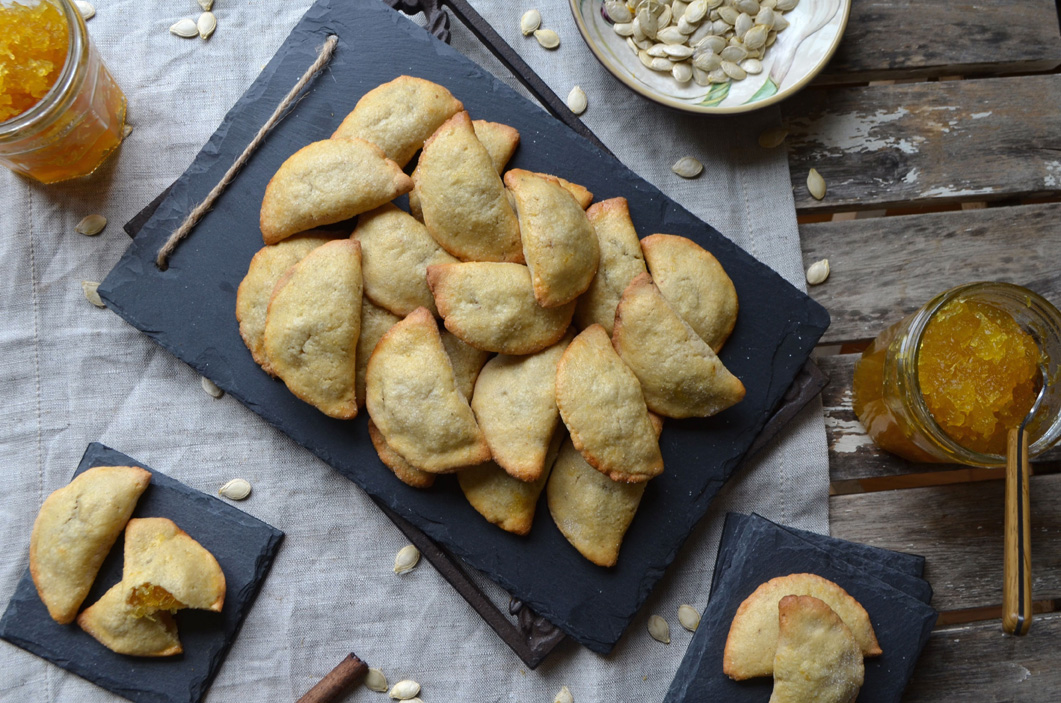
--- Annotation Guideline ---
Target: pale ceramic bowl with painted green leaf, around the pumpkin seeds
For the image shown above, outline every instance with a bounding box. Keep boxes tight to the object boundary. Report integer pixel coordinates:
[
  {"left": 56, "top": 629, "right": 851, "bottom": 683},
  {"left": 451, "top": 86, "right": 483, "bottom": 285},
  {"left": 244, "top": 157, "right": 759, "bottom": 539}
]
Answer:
[{"left": 571, "top": 0, "right": 851, "bottom": 113}]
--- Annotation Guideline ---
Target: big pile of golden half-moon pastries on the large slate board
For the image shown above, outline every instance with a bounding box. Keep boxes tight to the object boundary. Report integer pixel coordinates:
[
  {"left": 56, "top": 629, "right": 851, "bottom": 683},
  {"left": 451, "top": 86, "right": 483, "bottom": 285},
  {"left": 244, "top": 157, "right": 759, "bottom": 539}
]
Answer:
[{"left": 237, "top": 75, "right": 745, "bottom": 566}]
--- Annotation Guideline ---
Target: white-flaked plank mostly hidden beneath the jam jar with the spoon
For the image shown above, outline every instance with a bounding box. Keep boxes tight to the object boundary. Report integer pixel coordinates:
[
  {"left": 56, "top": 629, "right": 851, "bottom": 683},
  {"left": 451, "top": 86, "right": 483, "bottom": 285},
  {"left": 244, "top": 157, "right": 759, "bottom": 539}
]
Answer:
[{"left": 815, "top": 354, "right": 1061, "bottom": 481}]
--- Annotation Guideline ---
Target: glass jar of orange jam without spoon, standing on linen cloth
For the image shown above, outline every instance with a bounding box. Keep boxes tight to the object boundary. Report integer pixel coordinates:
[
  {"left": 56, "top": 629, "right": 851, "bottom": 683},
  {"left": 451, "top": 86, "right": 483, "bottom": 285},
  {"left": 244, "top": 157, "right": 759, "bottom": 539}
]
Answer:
[{"left": 0, "top": 0, "right": 125, "bottom": 183}]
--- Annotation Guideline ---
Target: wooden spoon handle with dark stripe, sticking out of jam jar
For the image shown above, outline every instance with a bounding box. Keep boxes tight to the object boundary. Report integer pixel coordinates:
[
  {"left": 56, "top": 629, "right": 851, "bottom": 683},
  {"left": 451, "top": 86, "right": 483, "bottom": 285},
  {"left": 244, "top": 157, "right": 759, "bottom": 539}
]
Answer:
[{"left": 1002, "top": 427, "right": 1031, "bottom": 635}]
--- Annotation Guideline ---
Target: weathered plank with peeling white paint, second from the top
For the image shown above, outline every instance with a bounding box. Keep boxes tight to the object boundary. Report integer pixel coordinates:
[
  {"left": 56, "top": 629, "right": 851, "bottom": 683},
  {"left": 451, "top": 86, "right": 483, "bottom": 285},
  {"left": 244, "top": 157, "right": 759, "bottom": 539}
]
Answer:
[{"left": 782, "top": 74, "right": 1061, "bottom": 212}]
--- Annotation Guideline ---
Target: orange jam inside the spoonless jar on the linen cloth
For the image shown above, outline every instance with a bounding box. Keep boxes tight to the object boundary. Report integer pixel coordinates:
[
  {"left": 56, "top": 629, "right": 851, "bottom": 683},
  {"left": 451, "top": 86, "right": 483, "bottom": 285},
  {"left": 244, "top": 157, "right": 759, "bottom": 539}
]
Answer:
[{"left": 0, "top": 2, "right": 69, "bottom": 122}]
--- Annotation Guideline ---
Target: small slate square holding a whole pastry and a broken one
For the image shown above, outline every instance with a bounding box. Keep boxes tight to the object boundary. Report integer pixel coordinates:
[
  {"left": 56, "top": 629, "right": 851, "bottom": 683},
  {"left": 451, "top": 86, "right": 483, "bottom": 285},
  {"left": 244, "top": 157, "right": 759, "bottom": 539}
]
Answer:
[{"left": 0, "top": 442, "right": 283, "bottom": 703}]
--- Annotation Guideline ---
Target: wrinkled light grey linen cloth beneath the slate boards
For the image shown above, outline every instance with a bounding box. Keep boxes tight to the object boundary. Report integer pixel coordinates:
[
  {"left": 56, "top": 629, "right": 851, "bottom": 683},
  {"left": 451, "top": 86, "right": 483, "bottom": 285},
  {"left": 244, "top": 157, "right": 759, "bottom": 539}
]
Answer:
[{"left": 0, "top": 0, "right": 828, "bottom": 703}]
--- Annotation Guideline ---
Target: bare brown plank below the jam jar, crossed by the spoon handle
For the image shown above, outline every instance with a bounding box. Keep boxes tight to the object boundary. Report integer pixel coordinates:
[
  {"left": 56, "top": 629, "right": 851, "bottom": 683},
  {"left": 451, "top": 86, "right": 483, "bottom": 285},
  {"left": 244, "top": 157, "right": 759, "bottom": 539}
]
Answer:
[{"left": 829, "top": 475, "right": 1061, "bottom": 614}]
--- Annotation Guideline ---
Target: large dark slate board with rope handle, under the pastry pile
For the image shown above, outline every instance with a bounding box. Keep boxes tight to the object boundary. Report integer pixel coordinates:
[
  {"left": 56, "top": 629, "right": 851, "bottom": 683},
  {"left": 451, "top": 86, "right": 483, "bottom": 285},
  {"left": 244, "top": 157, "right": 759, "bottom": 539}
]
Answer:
[{"left": 100, "top": 0, "right": 829, "bottom": 652}]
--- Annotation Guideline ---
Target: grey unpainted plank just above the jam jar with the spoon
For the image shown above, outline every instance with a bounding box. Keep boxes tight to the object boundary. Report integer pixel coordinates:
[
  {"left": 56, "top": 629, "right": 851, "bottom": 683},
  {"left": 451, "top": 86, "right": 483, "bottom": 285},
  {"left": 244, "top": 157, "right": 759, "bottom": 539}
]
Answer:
[{"left": 799, "top": 202, "right": 1061, "bottom": 344}]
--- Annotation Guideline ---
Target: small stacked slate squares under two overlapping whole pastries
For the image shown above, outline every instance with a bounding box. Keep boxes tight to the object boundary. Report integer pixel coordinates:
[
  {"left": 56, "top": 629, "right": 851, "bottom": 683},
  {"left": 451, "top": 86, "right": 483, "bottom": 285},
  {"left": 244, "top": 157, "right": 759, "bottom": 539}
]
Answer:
[{"left": 664, "top": 513, "right": 938, "bottom": 703}]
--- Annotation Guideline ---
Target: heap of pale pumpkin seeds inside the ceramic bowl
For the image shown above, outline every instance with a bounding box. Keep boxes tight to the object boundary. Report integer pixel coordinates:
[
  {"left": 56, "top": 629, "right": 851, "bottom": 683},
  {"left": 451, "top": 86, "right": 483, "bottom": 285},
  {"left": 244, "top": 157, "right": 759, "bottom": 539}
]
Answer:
[{"left": 604, "top": 0, "right": 799, "bottom": 86}]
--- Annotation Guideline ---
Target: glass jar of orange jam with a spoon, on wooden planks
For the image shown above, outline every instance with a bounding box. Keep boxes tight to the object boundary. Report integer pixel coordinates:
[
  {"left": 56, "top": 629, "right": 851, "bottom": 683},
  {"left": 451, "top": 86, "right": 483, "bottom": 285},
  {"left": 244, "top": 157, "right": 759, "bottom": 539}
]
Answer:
[{"left": 853, "top": 283, "right": 1061, "bottom": 467}]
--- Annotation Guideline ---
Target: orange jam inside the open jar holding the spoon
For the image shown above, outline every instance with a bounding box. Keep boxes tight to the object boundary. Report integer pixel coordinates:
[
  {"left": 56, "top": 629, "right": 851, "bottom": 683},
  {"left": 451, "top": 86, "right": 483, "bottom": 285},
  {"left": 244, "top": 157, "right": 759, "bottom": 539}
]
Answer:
[{"left": 918, "top": 299, "right": 1042, "bottom": 455}]
